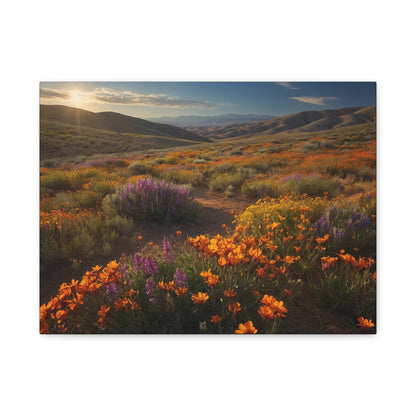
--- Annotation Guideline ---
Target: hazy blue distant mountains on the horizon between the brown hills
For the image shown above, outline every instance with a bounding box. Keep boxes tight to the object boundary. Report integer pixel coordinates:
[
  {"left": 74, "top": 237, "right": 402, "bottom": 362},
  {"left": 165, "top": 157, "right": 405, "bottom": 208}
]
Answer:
[{"left": 148, "top": 113, "right": 275, "bottom": 128}]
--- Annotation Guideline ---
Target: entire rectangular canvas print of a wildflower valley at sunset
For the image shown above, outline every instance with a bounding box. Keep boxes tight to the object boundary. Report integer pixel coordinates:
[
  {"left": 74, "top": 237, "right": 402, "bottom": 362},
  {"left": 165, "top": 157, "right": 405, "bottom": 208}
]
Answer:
[{"left": 39, "top": 82, "right": 376, "bottom": 335}]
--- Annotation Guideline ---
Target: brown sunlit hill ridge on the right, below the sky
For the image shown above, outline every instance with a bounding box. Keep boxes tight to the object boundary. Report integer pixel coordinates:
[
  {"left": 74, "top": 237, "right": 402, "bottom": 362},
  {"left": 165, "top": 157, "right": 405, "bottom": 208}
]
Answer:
[{"left": 190, "top": 106, "right": 376, "bottom": 139}]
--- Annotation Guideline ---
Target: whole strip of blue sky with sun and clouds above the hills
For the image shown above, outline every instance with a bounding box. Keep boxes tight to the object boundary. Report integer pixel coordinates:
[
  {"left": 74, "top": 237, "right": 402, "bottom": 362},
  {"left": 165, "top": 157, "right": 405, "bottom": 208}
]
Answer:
[{"left": 40, "top": 82, "right": 376, "bottom": 118}]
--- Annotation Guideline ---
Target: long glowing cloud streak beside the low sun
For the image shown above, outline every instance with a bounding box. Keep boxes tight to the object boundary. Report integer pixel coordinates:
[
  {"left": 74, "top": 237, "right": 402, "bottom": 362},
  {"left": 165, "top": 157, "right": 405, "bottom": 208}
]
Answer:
[{"left": 40, "top": 88, "right": 215, "bottom": 108}]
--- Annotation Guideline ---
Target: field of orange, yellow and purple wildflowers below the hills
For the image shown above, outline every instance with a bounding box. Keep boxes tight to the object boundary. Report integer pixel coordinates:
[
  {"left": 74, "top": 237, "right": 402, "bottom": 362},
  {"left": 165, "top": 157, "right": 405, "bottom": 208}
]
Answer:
[{"left": 40, "top": 124, "right": 376, "bottom": 334}]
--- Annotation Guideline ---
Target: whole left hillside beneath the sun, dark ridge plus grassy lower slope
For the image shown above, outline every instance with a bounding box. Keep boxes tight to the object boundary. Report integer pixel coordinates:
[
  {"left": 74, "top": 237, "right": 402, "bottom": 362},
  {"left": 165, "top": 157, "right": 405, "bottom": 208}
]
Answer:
[{"left": 40, "top": 105, "right": 210, "bottom": 162}]
